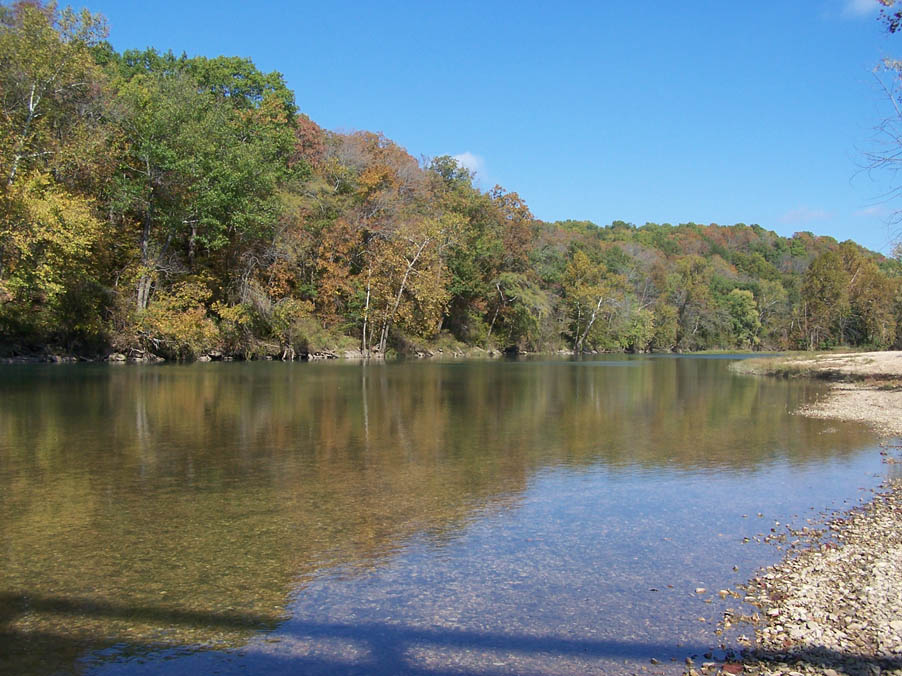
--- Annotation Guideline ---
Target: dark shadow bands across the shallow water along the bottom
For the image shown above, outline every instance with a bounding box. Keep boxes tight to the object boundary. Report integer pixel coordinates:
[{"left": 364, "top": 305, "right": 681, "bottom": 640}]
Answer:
[{"left": 0, "top": 594, "right": 720, "bottom": 676}]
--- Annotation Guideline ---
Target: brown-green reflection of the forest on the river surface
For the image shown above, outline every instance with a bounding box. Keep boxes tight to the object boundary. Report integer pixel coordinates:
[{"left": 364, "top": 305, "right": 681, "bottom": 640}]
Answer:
[{"left": 0, "top": 359, "right": 867, "bottom": 666}]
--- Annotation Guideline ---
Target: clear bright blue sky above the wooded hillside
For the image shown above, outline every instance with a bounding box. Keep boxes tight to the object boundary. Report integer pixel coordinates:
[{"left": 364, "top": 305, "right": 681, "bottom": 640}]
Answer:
[{"left": 79, "top": 0, "right": 902, "bottom": 254}]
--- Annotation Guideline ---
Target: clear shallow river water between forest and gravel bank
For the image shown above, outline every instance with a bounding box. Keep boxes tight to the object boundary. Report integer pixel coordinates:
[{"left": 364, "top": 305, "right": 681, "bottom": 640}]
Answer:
[{"left": 0, "top": 358, "right": 883, "bottom": 674}]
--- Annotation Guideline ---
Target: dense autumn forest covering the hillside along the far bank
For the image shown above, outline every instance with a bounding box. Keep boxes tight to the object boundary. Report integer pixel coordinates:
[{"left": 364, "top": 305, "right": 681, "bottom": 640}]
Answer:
[{"left": 0, "top": 2, "right": 902, "bottom": 359}]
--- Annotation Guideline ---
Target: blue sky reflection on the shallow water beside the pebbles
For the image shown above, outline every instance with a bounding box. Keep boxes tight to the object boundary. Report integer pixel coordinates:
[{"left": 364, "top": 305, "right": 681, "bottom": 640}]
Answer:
[{"left": 88, "top": 449, "right": 884, "bottom": 675}]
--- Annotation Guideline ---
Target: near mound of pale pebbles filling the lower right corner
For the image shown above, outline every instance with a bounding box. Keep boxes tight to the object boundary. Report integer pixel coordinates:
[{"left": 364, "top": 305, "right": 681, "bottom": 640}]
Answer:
[{"left": 696, "top": 483, "right": 902, "bottom": 676}]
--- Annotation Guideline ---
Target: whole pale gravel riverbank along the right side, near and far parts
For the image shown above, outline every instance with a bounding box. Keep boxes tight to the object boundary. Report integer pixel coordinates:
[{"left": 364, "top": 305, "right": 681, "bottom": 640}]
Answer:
[{"left": 716, "top": 352, "right": 902, "bottom": 676}]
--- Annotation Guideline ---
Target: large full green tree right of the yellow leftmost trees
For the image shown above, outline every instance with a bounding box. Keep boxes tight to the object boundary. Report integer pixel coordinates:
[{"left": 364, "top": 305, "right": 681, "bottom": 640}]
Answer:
[{"left": 113, "top": 61, "right": 293, "bottom": 310}]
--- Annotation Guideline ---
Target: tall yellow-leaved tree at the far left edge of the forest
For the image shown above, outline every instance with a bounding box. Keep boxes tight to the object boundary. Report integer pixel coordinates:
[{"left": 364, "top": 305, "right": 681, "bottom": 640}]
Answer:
[{"left": 0, "top": 2, "right": 106, "bottom": 344}]
